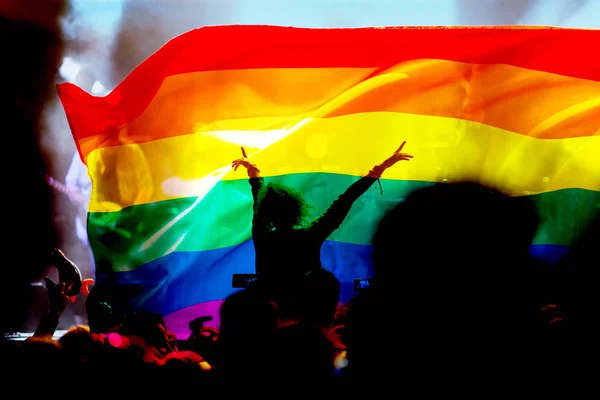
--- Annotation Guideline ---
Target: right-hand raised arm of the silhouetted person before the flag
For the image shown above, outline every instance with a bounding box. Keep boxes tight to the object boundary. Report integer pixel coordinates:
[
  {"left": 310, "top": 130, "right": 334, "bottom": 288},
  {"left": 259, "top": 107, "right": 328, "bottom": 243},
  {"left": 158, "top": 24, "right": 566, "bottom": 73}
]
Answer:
[{"left": 309, "top": 142, "right": 412, "bottom": 241}]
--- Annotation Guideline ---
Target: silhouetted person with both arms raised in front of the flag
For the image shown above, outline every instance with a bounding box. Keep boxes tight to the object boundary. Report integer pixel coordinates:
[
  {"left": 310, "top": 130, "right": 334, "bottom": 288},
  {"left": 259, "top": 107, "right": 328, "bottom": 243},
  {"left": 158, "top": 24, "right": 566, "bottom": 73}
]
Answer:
[{"left": 232, "top": 142, "right": 412, "bottom": 314}]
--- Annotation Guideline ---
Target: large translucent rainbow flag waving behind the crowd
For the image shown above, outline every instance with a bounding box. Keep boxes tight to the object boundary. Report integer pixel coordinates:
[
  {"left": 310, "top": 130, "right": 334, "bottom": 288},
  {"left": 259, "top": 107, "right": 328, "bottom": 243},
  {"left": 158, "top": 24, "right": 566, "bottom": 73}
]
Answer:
[{"left": 58, "top": 26, "right": 600, "bottom": 332}]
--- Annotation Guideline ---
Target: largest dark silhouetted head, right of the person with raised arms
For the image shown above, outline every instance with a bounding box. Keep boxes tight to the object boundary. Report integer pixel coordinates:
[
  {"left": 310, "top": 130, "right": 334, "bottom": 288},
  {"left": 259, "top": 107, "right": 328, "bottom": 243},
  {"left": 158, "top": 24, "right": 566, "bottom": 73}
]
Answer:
[{"left": 373, "top": 182, "right": 539, "bottom": 330}]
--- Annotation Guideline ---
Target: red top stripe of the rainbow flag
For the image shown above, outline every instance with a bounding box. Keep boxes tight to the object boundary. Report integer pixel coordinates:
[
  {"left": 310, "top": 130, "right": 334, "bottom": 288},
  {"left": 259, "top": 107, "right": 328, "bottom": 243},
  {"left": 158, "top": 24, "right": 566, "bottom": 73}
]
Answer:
[{"left": 58, "top": 26, "right": 600, "bottom": 151}]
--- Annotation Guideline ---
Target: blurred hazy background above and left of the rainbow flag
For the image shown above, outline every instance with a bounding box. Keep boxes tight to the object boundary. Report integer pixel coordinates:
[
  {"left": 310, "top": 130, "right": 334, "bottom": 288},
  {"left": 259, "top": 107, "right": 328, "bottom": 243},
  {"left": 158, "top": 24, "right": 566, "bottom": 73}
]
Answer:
[{"left": 0, "top": 0, "right": 600, "bottom": 330}]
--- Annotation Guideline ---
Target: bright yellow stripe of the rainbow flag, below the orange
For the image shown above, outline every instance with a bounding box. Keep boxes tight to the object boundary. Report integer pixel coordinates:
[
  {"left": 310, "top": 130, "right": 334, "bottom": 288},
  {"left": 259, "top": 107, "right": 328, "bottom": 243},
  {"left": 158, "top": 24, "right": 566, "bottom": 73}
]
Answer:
[{"left": 88, "top": 112, "right": 600, "bottom": 211}]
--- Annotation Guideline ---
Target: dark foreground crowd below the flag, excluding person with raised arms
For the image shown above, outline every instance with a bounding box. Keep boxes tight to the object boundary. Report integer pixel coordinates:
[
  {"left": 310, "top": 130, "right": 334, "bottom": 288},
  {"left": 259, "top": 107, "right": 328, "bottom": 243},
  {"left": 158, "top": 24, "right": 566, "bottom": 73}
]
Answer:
[{"left": 2, "top": 177, "right": 600, "bottom": 390}]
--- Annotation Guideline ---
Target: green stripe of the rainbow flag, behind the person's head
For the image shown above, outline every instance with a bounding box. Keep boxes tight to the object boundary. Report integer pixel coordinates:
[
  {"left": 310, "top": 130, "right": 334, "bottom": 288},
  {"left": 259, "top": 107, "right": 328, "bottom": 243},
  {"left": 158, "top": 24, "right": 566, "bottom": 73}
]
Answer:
[{"left": 88, "top": 173, "right": 600, "bottom": 271}]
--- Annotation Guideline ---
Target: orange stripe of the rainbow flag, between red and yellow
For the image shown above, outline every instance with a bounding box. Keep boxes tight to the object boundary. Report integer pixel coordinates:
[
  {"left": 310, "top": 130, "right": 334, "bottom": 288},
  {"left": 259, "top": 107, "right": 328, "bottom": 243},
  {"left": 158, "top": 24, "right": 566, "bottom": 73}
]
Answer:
[{"left": 79, "top": 60, "right": 600, "bottom": 156}]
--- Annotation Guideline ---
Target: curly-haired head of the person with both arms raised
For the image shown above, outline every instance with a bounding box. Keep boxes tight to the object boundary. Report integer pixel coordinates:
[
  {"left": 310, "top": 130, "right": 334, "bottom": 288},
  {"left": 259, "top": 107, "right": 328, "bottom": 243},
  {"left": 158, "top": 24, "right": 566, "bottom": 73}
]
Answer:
[{"left": 257, "top": 183, "right": 310, "bottom": 230}]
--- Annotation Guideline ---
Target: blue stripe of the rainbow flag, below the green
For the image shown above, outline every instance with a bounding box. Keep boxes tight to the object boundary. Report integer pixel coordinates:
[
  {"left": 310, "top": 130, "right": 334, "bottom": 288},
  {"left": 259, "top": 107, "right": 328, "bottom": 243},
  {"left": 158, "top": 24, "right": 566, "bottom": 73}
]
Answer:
[{"left": 97, "top": 240, "right": 568, "bottom": 315}]
